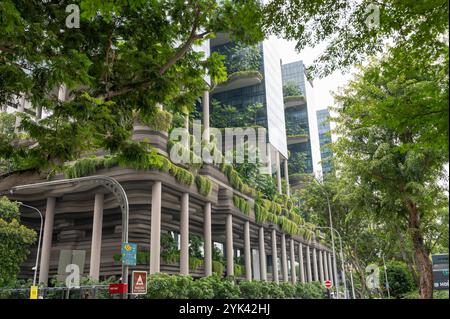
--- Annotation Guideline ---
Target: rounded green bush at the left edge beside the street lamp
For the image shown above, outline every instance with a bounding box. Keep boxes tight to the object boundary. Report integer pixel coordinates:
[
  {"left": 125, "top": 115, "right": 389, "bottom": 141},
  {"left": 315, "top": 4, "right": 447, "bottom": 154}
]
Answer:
[{"left": 0, "top": 197, "right": 36, "bottom": 287}]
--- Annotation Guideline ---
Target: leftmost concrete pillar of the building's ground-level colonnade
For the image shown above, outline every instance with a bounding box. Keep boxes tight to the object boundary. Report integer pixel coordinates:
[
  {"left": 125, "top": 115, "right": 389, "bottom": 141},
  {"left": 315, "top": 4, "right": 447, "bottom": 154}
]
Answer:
[{"left": 39, "top": 197, "right": 56, "bottom": 285}]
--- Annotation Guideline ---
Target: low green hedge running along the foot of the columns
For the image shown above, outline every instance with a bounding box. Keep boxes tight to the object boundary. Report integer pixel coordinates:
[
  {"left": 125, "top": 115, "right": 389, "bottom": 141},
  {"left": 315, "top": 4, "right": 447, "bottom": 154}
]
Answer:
[{"left": 144, "top": 273, "right": 325, "bottom": 299}]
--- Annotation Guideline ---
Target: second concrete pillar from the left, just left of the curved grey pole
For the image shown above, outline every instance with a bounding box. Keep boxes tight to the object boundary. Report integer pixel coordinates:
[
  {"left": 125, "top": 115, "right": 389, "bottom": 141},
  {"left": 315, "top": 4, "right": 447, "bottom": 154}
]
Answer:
[{"left": 89, "top": 193, "right": 105, "bottom": 281}]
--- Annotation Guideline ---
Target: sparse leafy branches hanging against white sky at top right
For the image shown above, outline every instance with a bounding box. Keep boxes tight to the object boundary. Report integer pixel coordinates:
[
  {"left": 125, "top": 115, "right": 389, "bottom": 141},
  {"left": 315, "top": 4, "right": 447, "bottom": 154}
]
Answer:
[{"left": 264, "top": 0, "right": 449, "bottom": 77}]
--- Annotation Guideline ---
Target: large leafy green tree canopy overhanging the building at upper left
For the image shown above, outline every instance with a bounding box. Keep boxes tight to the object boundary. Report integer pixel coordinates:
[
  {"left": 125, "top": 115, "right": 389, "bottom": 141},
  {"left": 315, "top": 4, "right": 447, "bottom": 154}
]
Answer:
[{"left": 0, "top": 0, "right": 264, "bottom": 169}]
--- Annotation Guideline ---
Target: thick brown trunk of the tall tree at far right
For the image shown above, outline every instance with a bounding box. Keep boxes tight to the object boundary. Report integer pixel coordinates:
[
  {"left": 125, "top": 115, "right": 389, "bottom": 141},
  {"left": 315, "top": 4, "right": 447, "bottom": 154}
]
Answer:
[{"left": 408, "top": 201, "right": 433, "bottom": 299}]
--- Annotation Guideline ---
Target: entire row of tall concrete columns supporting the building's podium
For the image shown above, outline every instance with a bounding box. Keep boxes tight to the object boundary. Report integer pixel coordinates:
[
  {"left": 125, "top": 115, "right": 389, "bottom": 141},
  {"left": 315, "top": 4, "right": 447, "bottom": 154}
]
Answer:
[{"left": 39, "top": 185, "right": 335, "bottom": 283}]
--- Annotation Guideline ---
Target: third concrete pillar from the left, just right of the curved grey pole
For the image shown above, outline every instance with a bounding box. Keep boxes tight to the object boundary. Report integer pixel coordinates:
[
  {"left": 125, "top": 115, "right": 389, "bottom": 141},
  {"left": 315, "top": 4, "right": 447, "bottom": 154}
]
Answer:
[{"left": 150, "top": 181, "right": 162, "bottom": 274}]
